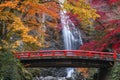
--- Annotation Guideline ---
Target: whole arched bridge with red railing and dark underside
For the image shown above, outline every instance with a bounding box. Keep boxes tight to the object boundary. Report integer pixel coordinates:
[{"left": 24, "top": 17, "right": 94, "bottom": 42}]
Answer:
[{"left": 15, "top": 50, "right": 116, "bottom": 68}]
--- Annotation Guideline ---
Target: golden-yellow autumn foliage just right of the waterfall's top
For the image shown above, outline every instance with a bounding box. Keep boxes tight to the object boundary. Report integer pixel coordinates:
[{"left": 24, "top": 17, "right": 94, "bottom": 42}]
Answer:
[{"left": 64, "top": 0, "right": 99, "bottom": 26}]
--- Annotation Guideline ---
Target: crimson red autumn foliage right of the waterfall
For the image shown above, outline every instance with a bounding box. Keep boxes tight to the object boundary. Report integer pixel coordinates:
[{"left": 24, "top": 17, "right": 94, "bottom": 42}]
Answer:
[{"left": 81, "top": 0, "right": 120, "bottom": 53}]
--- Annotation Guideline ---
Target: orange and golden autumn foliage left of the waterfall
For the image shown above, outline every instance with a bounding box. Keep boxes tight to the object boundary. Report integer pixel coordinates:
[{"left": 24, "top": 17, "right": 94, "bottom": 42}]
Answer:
[{"left": 0, "top": 0, "right": 59, "bottom": 49}]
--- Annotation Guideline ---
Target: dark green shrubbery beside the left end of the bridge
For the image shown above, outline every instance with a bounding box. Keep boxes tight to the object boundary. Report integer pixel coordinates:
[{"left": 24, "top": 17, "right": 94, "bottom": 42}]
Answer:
[{"left": 0, "top": 50, "right": 32, "bottom": 80}]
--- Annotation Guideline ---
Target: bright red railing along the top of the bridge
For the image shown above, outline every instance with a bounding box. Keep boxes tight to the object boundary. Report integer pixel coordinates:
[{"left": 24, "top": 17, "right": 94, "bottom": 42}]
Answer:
[{"left": 15, "top": 50, "right": 116, "bottom": 60}]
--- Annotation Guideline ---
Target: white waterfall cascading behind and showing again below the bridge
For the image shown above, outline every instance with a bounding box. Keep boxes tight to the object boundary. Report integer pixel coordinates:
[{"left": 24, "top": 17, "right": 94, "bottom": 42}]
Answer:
[{"left": 61, "top": 10, "right": 83, "bottom": 77}]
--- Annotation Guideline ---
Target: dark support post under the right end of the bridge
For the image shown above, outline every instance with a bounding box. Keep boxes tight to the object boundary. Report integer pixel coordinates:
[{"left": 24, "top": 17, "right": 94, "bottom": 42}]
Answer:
[{"left": 97, "top": 67, "right": 111, "bottom": 80}]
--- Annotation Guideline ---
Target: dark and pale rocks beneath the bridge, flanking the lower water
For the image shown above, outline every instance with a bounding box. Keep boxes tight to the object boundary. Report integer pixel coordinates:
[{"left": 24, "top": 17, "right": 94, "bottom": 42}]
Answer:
[{"left": 33, "top": 68, "right": 85, "bottom": 80}]
